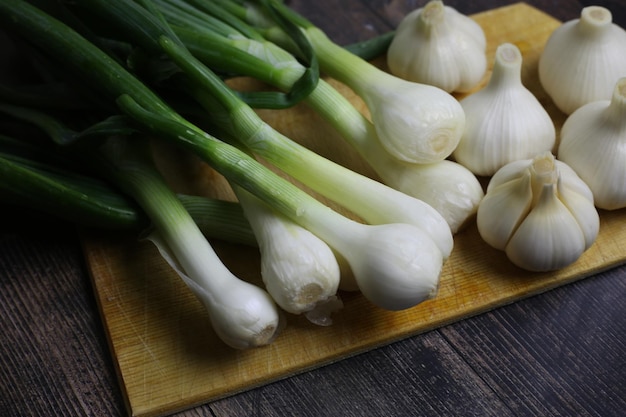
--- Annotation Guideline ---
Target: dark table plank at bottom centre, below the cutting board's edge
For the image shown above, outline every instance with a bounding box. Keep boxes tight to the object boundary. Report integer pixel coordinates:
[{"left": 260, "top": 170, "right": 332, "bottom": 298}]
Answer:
[{"left": 207, "top": 331, "right": 514, "bottom": 417}]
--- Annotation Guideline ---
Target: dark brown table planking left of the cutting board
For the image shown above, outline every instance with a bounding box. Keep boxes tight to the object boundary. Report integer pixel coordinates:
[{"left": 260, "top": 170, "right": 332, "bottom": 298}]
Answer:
[{"left": 0, "top": 213, "right": 125, "bottom": 416}]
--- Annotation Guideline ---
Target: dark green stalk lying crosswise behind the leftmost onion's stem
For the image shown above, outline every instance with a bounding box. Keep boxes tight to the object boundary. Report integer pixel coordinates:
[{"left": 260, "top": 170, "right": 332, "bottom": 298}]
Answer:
[{"left": 0, "top": 135, "right": 257, "bottom": 247}]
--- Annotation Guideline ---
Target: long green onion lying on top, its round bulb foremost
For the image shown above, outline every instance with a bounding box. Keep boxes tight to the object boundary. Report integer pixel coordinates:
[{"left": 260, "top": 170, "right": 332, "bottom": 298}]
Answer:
[{"left": 0, "top": 1, "right": 443, "bottom": 310}]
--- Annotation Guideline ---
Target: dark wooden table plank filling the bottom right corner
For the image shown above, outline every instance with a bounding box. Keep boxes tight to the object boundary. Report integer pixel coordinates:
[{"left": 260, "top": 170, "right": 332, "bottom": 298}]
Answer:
[{"left": 441, "top": 270, "right": 626, "bottom": 417}]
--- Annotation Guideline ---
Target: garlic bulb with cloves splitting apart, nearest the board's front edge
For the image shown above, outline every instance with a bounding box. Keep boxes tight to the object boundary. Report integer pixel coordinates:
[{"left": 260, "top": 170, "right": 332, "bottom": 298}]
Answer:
[{"left": 476, "top": 152, "right": 600, "bottom": 271}]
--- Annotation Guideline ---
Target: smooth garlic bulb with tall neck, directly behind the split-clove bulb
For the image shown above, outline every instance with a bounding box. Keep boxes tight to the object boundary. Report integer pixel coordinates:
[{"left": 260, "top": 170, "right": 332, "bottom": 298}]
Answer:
[{"left": 453, "top": 43, "right": 556, "bottom": 175}]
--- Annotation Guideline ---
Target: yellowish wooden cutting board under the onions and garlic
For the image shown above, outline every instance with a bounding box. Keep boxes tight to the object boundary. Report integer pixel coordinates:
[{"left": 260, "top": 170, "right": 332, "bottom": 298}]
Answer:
[{"left": 83, "top": 3, "right": 626, "bottom": 416}]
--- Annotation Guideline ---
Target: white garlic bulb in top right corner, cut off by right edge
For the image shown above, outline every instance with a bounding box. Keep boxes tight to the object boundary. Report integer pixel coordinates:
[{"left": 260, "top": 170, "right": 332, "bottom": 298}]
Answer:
[{"left": 539, "top": 6, "right": 626, "bottom": 114}]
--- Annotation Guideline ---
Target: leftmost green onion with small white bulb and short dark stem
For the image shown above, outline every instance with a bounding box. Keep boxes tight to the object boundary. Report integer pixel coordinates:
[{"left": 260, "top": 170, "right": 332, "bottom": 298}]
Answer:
[{"left": 100, "top": 137, "right": 282, "bottom": 349}]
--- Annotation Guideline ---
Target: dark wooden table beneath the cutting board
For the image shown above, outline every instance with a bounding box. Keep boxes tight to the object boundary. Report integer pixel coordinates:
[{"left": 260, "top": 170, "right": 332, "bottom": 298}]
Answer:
[{"left": 0, "top": 0, "right": 626, "bottom": 417}]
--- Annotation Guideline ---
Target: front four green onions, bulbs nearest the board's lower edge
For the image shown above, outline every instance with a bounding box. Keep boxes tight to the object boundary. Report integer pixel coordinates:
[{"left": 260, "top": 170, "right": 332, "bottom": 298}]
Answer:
[{"left": 0, "top": 0, "right": 452, "bottom": 348}]
